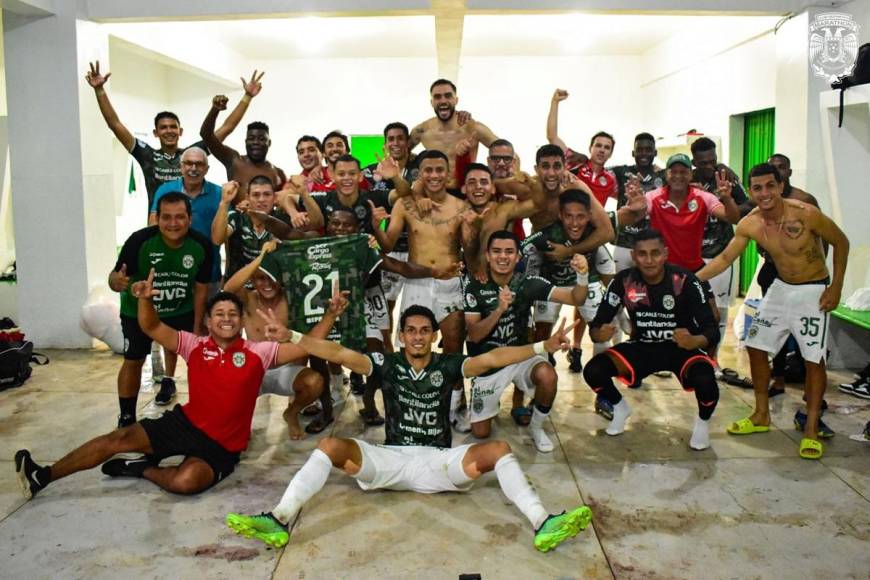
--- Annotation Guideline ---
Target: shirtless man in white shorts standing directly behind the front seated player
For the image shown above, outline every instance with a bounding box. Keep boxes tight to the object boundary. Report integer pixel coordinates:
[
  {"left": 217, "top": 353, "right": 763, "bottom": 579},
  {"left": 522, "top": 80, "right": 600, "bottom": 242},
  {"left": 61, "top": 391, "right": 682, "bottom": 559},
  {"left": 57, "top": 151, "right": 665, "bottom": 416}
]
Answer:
[{"left": 371, "top": 150, "right": 471, "bottom": 432}]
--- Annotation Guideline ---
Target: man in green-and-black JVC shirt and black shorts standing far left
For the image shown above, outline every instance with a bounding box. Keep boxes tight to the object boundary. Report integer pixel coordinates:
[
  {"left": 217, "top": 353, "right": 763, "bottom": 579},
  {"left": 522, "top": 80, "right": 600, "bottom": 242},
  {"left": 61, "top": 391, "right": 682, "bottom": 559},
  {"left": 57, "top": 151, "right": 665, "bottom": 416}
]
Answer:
[{"left": 109, "top": 192, "right": 212, "bottom": 427}]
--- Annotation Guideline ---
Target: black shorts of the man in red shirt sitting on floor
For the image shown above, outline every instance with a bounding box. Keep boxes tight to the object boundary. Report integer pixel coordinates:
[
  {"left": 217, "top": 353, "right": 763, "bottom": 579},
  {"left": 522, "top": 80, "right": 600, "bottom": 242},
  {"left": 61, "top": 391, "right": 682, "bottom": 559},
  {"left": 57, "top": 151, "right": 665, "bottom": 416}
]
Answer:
[{"left": 139, "top": 405, "right": 239, "bottom": 487}]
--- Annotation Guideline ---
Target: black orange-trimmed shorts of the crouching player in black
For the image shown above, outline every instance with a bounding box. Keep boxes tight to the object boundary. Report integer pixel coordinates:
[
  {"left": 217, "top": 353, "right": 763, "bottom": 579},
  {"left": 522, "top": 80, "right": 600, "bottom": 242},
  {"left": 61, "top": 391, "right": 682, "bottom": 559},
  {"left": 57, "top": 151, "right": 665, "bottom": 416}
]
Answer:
[{"left": 607, "top": 340, "right": 713, "bottom": 391}]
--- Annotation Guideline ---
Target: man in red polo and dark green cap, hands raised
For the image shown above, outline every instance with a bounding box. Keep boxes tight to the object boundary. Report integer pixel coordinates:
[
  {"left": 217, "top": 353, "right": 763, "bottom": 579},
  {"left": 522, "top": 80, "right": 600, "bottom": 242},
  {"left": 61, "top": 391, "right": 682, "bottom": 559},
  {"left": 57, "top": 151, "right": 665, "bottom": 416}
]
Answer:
[{"left": 617, "top": 153, "right": 740, "bottom": 272}]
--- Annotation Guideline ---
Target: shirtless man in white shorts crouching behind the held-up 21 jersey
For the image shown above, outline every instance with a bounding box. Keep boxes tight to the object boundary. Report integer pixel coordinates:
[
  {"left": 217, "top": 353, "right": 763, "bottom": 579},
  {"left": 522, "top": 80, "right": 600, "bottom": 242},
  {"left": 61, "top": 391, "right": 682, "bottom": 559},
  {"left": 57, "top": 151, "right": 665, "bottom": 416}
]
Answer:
[{"left": 223, "top": 240, "right": 332, "bottom": 440}]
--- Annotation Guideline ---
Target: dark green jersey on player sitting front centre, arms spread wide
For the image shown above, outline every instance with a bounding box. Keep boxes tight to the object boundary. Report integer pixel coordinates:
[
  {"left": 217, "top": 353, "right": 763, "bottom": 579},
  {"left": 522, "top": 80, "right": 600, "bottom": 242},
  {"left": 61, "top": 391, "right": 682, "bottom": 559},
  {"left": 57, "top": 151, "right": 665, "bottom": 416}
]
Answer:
[{"left": 366, "top": 349, "right": 468, "bottom": 447}]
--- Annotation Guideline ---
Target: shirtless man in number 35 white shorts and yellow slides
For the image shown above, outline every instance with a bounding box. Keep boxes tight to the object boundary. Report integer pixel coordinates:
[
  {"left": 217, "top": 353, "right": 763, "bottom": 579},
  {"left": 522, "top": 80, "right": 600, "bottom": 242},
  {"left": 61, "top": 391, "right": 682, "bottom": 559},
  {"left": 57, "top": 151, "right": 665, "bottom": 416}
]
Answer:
[{"left": 698, "top": 163, "right": 849, "bottom": 459}]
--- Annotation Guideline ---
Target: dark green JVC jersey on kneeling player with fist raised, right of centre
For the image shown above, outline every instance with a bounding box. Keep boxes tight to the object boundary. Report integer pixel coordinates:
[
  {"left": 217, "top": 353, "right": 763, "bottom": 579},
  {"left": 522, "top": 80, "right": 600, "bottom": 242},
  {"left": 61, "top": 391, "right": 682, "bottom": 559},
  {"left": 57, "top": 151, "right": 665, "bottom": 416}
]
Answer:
[{"left": 465, "top": 272, "right": 553, "bottom": 358}]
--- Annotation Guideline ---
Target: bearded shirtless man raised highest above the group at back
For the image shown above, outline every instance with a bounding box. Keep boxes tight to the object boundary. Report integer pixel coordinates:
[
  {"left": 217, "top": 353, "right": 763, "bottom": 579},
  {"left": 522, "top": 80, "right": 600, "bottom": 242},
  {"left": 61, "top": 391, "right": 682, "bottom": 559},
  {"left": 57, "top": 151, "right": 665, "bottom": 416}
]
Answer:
[{"left": 408, "top": 79, "right": 498, "bottom": 191}]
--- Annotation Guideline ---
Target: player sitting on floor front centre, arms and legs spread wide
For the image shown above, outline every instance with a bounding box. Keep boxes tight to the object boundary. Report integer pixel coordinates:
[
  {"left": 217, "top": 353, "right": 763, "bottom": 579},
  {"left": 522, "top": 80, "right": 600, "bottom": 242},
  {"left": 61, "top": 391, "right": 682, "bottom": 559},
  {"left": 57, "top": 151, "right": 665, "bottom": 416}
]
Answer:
[{"left": 226, "top": 305, "right": 592, "bottom": 552}]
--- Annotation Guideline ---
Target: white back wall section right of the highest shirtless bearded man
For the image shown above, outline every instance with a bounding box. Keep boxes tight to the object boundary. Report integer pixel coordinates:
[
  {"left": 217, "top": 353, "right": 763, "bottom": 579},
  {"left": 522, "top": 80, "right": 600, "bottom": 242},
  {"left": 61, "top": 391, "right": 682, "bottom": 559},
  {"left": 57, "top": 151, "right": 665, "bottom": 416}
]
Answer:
[{"left": 460, "top": 56, "right": 646, "bottom": 172}]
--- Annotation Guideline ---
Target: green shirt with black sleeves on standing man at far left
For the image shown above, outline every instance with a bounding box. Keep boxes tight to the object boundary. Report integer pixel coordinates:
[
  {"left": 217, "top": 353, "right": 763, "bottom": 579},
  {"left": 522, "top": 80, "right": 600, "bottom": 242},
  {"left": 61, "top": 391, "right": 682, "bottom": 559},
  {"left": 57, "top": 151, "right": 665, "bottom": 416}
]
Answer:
[{"left": 115, "top": 226, "right": 212, "bottom": 318}]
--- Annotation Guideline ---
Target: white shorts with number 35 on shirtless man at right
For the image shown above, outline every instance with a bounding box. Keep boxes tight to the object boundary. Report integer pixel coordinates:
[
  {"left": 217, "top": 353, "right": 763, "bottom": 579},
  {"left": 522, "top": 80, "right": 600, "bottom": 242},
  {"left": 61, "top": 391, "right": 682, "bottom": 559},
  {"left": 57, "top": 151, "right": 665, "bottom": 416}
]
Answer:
[{"left": 746, "top": 278, "right": 830, "bottom": 363}]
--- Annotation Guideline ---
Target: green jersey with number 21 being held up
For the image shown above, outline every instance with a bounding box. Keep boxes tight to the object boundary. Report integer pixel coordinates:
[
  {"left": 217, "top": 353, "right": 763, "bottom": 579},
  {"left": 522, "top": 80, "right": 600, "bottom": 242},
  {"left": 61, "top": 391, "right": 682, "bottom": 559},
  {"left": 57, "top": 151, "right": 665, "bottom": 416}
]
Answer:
[{"left": 260, "top": 234, "right": 383, "bottom": 351}]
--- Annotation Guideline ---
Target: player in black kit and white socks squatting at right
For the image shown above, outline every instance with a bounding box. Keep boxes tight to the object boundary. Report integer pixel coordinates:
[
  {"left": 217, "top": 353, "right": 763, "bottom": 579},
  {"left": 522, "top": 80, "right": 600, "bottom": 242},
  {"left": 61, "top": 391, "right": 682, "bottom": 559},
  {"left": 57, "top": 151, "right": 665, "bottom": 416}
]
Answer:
[{"left": 583, "top": 229, "right": 719, "bottom": 450}]
